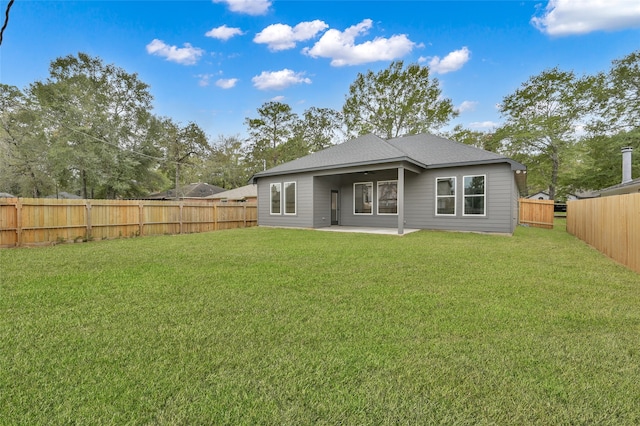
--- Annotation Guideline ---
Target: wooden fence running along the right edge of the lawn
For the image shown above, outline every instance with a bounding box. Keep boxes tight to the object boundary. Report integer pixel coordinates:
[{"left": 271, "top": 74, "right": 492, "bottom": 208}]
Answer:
[{"left": 567, "top": 194, "right": 640, "bottom": 272}]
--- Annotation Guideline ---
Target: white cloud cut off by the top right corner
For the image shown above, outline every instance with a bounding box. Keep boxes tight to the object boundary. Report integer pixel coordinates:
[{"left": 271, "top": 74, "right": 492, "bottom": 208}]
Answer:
[{"left": 531, "top": 0, "right": 640, "bottom": 36}]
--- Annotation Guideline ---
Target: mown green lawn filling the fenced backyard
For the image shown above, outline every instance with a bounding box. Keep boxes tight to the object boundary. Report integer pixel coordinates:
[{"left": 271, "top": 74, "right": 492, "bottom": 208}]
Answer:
[{"left": 0, "top": 220, "right": 640, "bottom": 425}]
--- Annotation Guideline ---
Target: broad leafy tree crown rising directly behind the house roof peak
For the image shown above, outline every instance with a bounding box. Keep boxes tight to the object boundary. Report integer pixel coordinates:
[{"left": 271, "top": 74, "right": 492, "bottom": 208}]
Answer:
[{"left": 342, "top": 61, "right": 458, "bottom": 139}]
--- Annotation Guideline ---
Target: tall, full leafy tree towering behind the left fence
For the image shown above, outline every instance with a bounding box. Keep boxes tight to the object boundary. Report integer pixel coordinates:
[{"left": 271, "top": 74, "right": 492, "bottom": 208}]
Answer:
[{"left": 29, "top": 53, "right": 158, "bottom": 198}]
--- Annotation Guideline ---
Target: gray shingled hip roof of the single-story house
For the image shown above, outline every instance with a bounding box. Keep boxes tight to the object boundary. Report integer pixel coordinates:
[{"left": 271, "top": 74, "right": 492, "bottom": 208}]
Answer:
[{"left": 251, "top": 134, "right": 526, "bottom": 190}]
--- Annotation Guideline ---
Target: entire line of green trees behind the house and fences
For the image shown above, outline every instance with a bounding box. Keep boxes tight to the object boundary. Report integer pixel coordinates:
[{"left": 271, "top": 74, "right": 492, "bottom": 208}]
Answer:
[{"left": 0, "top": 51, "right": 640, "bottom": 198}]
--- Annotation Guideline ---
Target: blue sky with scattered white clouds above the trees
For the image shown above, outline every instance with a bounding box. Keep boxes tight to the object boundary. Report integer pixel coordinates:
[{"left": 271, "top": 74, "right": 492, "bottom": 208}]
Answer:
[{"left": 0, "top": 0, "right": 640, "bottom": 143}]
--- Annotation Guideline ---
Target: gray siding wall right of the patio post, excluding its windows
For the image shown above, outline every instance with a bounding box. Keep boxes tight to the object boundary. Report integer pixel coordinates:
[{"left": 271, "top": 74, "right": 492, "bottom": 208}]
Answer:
[{"left": 405, "top": 164, "right": 515, "bottom": 233}]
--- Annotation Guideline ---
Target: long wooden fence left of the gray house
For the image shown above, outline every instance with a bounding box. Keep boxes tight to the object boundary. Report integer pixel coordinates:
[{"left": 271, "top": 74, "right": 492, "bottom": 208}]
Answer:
[{"left": 0, "top": 198, "right": 258, "bottom": 247}]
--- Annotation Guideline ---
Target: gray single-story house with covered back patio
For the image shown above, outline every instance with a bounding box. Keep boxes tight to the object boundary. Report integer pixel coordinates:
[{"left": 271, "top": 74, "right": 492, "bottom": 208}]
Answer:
[{"left": 251, "top": 134, "right": 526, "bottom": 234}]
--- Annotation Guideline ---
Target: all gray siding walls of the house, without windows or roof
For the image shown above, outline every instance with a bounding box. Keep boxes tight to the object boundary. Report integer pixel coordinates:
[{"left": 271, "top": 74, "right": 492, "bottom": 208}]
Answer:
[{"left": 258, "top": 163, "right": 518, "bottom": 234}]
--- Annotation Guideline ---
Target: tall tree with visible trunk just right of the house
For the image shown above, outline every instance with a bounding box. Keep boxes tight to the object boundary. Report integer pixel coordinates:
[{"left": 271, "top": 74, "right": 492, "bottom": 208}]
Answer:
[{"left": 496, "top": 68, "right": 588, "bottom": 199}]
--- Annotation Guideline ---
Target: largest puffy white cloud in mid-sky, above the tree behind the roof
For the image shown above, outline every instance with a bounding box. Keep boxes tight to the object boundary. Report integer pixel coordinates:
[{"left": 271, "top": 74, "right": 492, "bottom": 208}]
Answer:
[{"left": 303, "top": 19, "right": 416, "bottom": 67}]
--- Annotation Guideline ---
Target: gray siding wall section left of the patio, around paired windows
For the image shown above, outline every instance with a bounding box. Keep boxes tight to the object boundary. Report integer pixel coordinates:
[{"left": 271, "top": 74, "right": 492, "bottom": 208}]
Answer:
[{"left": 258, "top": 174, "right": 313, "bottom": 228}]
